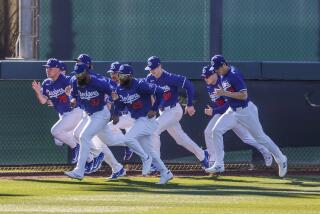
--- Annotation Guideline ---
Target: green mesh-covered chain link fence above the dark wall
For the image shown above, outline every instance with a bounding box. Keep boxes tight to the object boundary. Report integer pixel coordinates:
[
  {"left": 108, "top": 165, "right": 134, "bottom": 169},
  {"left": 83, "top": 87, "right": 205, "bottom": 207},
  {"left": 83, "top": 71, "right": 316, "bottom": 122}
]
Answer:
[{"left": 40, "top": 0, "right": 320, "bottom": 61}]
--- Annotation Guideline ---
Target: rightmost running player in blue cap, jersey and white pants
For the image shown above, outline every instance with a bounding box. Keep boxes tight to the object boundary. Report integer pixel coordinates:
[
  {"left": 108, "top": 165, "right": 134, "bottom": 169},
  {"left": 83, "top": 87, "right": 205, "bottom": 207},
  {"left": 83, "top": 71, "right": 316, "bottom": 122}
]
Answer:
[{"left": 206, "top": 55, "right": 287, "bottom": 177}]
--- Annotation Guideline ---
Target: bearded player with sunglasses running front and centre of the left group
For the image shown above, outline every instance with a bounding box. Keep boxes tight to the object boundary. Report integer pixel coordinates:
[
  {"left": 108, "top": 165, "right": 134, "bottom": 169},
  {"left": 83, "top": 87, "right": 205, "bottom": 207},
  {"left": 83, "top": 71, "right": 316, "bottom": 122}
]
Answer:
[{"left": 113, "top": 64, "right": 173, "bottom": 184}]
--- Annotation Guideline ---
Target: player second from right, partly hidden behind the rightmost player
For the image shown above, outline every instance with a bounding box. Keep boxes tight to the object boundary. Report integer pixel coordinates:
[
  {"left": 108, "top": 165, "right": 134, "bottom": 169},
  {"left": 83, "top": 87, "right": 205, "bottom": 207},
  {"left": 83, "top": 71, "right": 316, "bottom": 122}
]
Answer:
[{"left": 201, "top": 65, "right": 272, "bottom": 167}]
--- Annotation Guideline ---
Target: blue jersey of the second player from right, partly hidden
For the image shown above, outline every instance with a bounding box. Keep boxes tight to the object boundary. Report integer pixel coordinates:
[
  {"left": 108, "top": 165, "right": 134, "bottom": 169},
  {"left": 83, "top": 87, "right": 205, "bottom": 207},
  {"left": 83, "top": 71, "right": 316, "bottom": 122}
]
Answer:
[{"left": 207, "top": 79, "right": 229, "bottom": 115}]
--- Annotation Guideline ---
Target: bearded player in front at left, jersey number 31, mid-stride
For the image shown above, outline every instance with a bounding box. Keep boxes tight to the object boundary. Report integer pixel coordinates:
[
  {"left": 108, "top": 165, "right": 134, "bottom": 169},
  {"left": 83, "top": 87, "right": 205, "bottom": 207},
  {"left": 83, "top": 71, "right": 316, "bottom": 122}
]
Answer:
[{"left": 65, "top": 63, "right": 152, "bottom": 180}]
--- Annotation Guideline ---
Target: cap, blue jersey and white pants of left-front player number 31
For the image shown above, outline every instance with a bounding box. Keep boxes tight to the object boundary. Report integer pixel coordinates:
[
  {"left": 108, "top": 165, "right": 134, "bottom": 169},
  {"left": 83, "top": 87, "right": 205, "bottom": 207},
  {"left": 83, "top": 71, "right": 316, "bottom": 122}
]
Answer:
[{"left": 66, "top": 64, "right": 123, "bottom": 179}]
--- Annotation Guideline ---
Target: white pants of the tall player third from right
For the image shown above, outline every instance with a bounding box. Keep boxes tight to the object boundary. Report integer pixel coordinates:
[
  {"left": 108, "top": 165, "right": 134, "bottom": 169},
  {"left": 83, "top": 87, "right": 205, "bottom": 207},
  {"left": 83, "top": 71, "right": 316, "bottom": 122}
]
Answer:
[{"left": 152, "top": 103, "right": 205, "bottom": 161}]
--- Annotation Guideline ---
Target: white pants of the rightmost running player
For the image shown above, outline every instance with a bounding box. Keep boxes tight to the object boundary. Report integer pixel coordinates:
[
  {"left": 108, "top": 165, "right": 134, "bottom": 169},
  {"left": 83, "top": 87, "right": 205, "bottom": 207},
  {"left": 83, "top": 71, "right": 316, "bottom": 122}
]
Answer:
[{"left": 212, "top": 102, "right": 286, "bottom": 165}]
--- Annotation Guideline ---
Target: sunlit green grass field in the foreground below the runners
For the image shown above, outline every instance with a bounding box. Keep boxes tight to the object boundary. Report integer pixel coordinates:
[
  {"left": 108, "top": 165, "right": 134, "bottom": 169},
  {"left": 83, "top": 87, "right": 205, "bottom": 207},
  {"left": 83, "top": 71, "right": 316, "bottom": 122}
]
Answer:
[{"left": 0, "top": 176, "right": 320, "bottom": 214}]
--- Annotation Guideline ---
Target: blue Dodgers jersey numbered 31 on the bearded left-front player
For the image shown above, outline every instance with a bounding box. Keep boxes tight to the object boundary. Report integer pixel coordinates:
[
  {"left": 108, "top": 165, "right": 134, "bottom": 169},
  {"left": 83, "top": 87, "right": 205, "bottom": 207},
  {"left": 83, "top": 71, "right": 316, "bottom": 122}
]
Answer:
[{"left": 71, "top": 73, "right": 112, "bottom": 114}]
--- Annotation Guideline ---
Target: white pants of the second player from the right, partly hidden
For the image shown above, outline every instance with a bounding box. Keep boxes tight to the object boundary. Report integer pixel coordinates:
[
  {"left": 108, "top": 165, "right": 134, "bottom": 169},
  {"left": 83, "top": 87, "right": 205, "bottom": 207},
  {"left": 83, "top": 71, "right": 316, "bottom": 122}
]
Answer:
[{"left": 204, "top": 114, "right": 270, "bottom": 163}]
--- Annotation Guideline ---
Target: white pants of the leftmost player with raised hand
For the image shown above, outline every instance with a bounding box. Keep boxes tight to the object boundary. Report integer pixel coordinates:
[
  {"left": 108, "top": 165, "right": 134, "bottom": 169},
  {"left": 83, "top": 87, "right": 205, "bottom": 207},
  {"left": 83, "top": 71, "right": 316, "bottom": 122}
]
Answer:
[{"left": 51, "top": 108, "right": 82, "bottom": 149}]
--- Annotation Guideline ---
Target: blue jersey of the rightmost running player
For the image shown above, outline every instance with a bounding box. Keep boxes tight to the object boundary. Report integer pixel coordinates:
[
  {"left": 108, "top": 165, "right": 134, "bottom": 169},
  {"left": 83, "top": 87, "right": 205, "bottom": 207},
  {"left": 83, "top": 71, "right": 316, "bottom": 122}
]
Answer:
[{"left": 221, "top": 66, "right": 249, "bottom": 110}]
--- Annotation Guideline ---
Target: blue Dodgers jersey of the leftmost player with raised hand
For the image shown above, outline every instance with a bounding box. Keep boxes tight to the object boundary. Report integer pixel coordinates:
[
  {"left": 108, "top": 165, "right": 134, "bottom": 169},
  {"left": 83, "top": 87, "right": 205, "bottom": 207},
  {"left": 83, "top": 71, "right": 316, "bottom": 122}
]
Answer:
[{"left": 42, "top": 74, "right": 72, "bottom": 114}]
